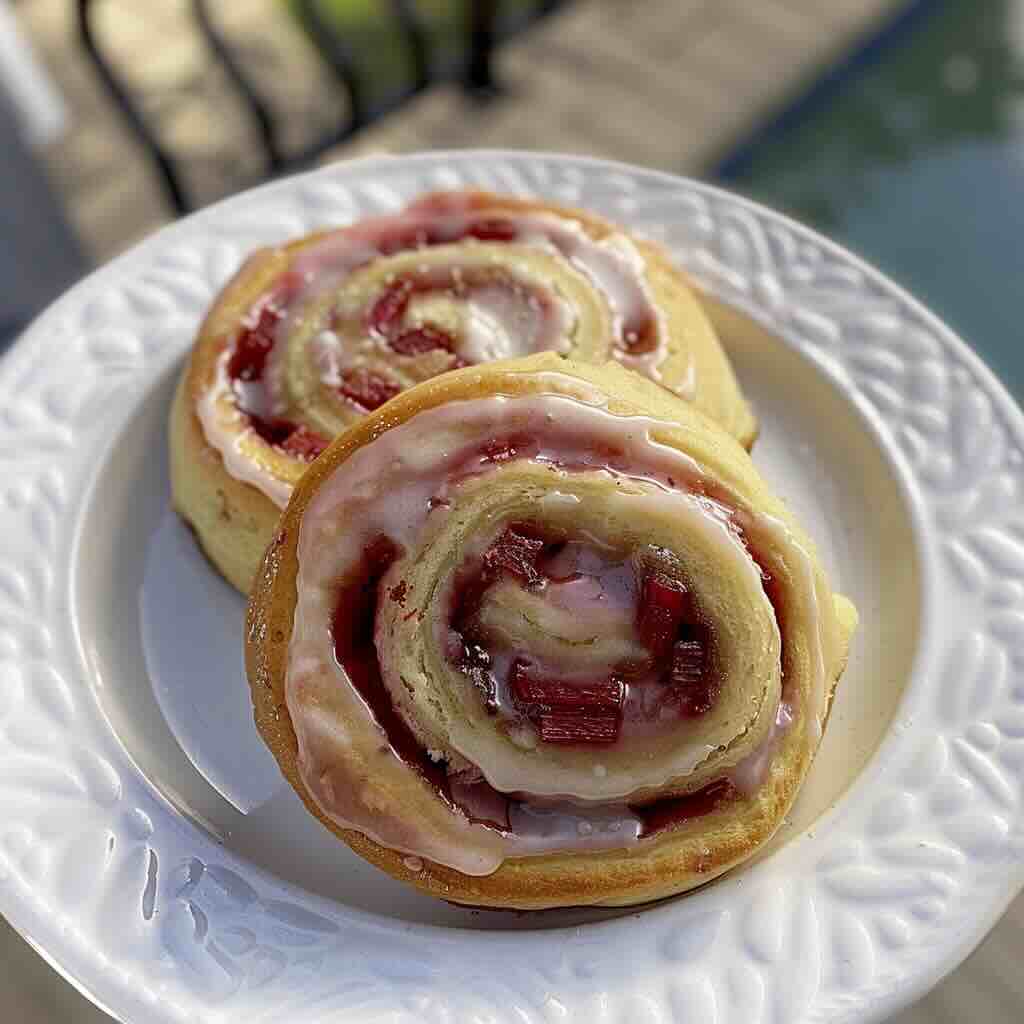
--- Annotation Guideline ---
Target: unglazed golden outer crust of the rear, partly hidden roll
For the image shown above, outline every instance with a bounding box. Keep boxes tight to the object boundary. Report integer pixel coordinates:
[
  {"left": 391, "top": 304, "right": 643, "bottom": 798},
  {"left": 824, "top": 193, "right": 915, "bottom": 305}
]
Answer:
[{"left": 170, "top": 191, "right": 757, "bottom": 594}]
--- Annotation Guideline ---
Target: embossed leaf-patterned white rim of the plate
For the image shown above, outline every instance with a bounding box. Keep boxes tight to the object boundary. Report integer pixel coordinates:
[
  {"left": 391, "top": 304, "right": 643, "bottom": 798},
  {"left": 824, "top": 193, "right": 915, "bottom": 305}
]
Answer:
[{"left": 0, "top": 153, "right": 1024, "bottom": 1024}]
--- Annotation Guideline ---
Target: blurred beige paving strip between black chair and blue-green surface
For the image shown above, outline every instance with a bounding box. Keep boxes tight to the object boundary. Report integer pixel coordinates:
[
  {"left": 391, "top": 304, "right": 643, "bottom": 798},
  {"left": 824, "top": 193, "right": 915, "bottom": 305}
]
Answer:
[{"left": 327, "top": 0, "right": 905, "bottom": 175}]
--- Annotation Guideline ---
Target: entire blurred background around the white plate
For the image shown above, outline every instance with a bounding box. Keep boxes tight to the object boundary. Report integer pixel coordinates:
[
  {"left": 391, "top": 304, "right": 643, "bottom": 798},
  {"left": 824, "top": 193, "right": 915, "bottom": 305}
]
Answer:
[{"left": 0, "top": 0, "right": 1024, "bottom": 1024}]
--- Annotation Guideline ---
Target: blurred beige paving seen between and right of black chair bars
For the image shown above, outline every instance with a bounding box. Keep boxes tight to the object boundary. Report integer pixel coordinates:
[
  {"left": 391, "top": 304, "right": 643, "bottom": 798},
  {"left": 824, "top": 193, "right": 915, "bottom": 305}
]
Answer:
[{"left": 18, "top": 0, "right": 905, "bottom": 261}]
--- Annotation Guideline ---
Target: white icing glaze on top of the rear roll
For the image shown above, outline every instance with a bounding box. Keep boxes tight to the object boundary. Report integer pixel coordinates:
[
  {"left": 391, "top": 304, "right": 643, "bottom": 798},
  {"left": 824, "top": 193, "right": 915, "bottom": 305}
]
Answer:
[{"left": 197, "top": 197, "right": 696, "bottom": 507}]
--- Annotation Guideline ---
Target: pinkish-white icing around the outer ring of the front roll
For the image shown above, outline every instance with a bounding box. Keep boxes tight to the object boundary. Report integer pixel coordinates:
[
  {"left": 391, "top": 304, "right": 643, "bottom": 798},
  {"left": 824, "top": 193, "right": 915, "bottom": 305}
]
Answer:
[{"left": 285, "top": 385, "right": 825, "bottom": 874}]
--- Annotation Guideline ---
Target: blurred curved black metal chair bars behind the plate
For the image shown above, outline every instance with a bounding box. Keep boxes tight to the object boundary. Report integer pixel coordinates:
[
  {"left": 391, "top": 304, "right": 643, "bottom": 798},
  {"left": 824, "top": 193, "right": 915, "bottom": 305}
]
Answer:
[{"left": 78, "top": 0, "right": 563, "bottom": 214}]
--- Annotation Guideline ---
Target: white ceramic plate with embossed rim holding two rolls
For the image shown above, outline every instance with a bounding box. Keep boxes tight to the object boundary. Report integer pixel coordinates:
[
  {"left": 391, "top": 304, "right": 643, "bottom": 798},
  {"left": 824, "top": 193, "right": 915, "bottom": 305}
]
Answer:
[{"left": 0, "top": 153, "right": 1024, "bottom": 1024}]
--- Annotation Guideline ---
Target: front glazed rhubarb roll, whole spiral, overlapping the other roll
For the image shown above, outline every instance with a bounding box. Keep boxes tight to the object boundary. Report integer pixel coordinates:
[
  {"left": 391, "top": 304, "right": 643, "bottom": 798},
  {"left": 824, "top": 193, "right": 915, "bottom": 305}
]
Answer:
[{"left": 247, "top": 353, "right": 856, "bottom": 908}]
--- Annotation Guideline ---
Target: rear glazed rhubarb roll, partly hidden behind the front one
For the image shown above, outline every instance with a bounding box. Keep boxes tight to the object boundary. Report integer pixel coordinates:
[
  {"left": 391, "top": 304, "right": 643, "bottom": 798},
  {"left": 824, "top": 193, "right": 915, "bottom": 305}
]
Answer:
[{"left": 171, "top": 191, "right": 756, "bottom": 592}]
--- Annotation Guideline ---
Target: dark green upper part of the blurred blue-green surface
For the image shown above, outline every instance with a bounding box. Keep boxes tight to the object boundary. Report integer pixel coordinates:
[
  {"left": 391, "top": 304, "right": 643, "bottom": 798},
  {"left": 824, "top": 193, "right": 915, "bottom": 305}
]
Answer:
[{"left": 730, "top": 0, "right": 1024, "bottom": 231}]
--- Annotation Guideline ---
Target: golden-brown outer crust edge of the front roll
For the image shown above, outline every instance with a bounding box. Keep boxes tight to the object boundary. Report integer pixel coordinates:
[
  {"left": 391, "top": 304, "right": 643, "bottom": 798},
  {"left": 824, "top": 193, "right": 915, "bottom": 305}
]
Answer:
[{"left": 246, "top": 353, "right": 856, "bottom": 909}]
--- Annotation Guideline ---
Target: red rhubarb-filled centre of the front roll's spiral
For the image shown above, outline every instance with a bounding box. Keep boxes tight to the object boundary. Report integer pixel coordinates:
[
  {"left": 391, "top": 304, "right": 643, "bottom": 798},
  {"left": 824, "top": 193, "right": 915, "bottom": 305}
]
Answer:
[{"left": 449, "top": 523, "right": 719, "bottom": 745}]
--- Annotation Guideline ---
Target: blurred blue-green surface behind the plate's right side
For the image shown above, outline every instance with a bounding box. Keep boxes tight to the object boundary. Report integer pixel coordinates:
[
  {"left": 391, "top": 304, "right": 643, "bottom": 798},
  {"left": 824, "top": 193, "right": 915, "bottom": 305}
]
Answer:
[{"left": 719, "top": 0, "right": 1024, "bottom": 400}]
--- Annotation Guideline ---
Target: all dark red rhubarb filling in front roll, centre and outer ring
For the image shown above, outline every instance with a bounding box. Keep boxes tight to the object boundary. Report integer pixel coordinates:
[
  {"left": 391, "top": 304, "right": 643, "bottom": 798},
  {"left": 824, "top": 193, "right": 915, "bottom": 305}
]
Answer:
[{"left": 332, "top": 509, "right": 784, "bottom": 839}]
